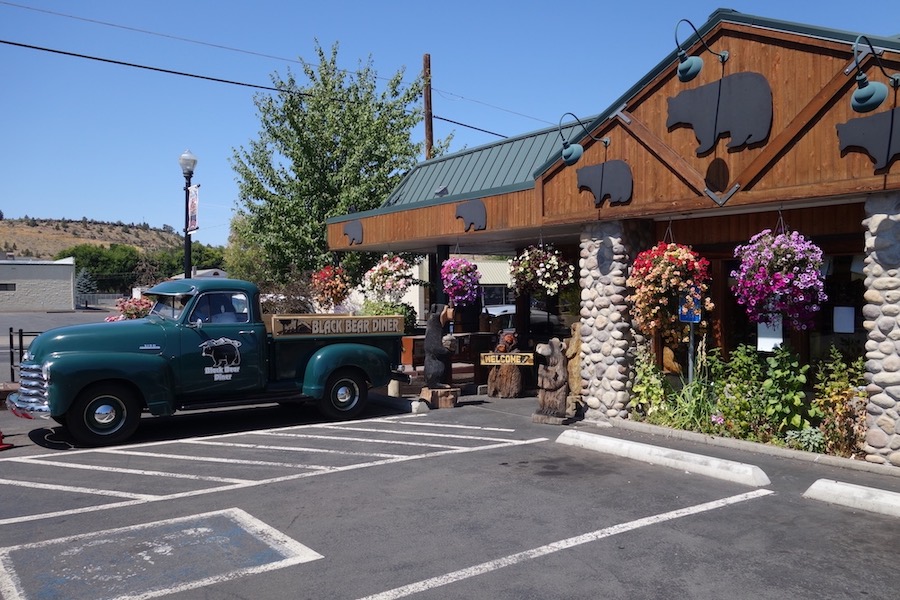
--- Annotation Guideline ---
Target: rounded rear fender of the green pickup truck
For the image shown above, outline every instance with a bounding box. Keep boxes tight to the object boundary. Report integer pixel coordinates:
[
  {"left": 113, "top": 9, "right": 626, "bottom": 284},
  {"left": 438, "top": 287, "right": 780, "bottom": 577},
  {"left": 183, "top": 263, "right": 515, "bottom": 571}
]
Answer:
[{"left": 303, "top": 344, "right": 391, "bottom": 399}]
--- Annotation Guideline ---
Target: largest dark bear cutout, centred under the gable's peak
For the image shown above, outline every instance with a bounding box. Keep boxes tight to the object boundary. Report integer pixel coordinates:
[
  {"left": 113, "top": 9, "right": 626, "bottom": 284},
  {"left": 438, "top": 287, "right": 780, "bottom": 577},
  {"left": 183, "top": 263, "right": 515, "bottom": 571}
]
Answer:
[{"left": 666, "top": 72, "right": 772, "bottom": 156}]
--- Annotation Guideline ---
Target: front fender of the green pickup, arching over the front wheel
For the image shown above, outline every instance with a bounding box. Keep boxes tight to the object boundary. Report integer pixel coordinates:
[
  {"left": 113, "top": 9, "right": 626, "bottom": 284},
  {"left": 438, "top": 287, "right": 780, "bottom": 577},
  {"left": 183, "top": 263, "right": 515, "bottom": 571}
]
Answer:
[{"left": 48, "top": 351, "right": 175, "bottom": 416}]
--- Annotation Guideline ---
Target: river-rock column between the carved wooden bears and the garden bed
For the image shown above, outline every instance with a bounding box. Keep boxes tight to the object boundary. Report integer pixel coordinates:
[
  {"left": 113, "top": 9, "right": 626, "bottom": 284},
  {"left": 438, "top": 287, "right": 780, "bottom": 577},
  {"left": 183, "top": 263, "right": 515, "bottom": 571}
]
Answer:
[{"left": 579, "top": 221, "right": 652, "bottom": 420}]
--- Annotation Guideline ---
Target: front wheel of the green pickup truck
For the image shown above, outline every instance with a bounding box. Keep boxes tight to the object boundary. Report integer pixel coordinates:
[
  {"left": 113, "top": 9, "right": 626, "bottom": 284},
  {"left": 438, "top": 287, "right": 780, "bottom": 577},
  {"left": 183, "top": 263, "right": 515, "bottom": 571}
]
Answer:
[{"left": 65, "top": 383, "right": 141, "bottom": 446}]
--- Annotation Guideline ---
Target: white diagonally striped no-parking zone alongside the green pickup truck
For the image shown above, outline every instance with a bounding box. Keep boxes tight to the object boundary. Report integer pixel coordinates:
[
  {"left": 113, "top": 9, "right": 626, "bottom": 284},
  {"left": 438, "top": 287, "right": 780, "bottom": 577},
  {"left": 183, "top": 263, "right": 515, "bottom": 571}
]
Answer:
[{"left": 0, "top": 415, "right": 546, "bottom": 525}]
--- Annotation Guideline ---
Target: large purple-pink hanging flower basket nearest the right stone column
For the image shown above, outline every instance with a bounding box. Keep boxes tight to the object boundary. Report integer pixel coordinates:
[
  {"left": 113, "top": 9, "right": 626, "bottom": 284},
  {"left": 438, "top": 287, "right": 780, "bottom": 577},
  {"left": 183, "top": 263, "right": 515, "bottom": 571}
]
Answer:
[{"left": 731, "top": 229, "right": 828, "bottom": 330}]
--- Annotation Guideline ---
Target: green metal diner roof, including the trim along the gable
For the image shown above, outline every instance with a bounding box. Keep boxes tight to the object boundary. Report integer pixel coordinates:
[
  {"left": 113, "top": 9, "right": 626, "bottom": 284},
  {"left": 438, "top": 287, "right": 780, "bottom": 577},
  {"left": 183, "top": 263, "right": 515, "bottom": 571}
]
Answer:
[{"left": 328, "top": 8, "right": 900, "bottom": 223}]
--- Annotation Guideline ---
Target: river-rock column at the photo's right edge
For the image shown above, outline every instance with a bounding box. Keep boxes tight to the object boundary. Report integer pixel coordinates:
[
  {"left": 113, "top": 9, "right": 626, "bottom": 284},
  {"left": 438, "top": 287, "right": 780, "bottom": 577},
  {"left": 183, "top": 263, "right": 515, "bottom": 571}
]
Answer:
[{"left": 863, "top": 192, "right": 900, "bottom": 466}]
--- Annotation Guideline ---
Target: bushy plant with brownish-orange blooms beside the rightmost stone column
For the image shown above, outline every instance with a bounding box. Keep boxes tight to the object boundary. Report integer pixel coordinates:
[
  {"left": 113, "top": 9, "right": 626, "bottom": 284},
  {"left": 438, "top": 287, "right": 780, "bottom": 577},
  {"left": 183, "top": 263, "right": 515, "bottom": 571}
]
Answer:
[{"left": 813, "top": 345, "right": 866, "bottom": 457}]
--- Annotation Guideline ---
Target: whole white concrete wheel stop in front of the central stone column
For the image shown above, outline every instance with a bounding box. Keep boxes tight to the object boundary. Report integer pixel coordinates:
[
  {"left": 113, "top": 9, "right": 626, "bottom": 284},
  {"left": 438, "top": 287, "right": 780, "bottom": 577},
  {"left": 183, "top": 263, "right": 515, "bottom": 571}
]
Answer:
[{"left": 556, "top": 430, "right": 771, "bottom": 487}]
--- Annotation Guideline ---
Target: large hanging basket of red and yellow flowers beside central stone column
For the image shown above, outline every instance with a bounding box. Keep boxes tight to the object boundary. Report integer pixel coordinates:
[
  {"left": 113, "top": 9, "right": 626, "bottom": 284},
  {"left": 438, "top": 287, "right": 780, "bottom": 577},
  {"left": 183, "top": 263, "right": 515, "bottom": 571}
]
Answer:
[{"left": 626, "top": 242, "right": 713, "bottom": 344}]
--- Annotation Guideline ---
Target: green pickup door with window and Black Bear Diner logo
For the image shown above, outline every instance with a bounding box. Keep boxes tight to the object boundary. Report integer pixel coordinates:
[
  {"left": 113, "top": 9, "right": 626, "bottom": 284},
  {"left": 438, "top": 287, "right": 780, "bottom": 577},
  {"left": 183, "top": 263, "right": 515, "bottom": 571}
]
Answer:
[{"left": 175, "top": 292, "right": 267, "bottom": 398}]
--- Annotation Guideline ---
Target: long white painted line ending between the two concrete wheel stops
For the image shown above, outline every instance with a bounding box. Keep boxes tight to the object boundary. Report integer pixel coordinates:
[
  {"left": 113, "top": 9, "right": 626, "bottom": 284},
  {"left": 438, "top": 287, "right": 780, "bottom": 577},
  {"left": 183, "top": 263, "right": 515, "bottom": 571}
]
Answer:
[{"left": 360, "top": 490, "right": 774, "bottom": 600}]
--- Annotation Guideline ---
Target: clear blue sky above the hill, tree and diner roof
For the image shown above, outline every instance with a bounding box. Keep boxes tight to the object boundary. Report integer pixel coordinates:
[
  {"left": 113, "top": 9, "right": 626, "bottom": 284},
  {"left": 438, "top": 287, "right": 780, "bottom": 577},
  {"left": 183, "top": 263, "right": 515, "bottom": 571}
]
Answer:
[{"left": 0, "top": 0, "right": 900, "bottom": 245}]
